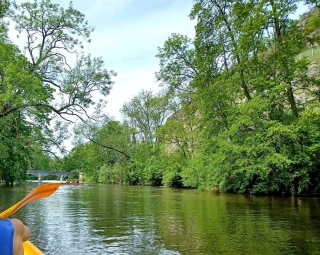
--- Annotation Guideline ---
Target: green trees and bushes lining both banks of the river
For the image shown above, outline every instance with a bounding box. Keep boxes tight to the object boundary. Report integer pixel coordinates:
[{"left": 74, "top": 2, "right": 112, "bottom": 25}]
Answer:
[{"left": 0, "top": 0, "right": 320, "bottom": 195}]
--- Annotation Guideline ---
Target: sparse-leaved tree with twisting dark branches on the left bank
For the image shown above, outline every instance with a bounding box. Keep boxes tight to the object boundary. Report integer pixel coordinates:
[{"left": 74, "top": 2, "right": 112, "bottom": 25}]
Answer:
[{"left": 1, "top": 0, "right": 114, "bottom": 149}]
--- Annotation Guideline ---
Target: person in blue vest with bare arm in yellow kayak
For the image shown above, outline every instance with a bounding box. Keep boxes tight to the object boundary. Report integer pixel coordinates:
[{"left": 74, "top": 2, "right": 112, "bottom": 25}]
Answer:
[{"left": 0, "top": 218, "right": 44, "bottom": 255}]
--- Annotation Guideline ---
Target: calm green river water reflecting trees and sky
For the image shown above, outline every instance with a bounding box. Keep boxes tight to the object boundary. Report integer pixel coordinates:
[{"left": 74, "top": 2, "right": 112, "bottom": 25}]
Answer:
[{"left": 0, "top": 183, "right": 320, "bottom": 255}]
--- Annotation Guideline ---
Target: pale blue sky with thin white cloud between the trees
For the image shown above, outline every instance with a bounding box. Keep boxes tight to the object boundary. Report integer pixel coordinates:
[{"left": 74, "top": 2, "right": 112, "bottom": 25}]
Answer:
[{"left": 13, "top": 0, "right": 195, "bottom": 121}]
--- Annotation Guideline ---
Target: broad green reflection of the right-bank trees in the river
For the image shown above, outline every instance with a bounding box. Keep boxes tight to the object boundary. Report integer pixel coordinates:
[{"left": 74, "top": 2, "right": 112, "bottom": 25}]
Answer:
[{"left": 156, "top": 190, "right": 320, "bottom": 254}]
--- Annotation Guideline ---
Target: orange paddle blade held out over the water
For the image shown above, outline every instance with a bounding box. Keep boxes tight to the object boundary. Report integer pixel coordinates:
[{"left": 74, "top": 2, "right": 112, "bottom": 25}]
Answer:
[{"left": 0, "top": 183, "right": 60, "bottom": 218}]
